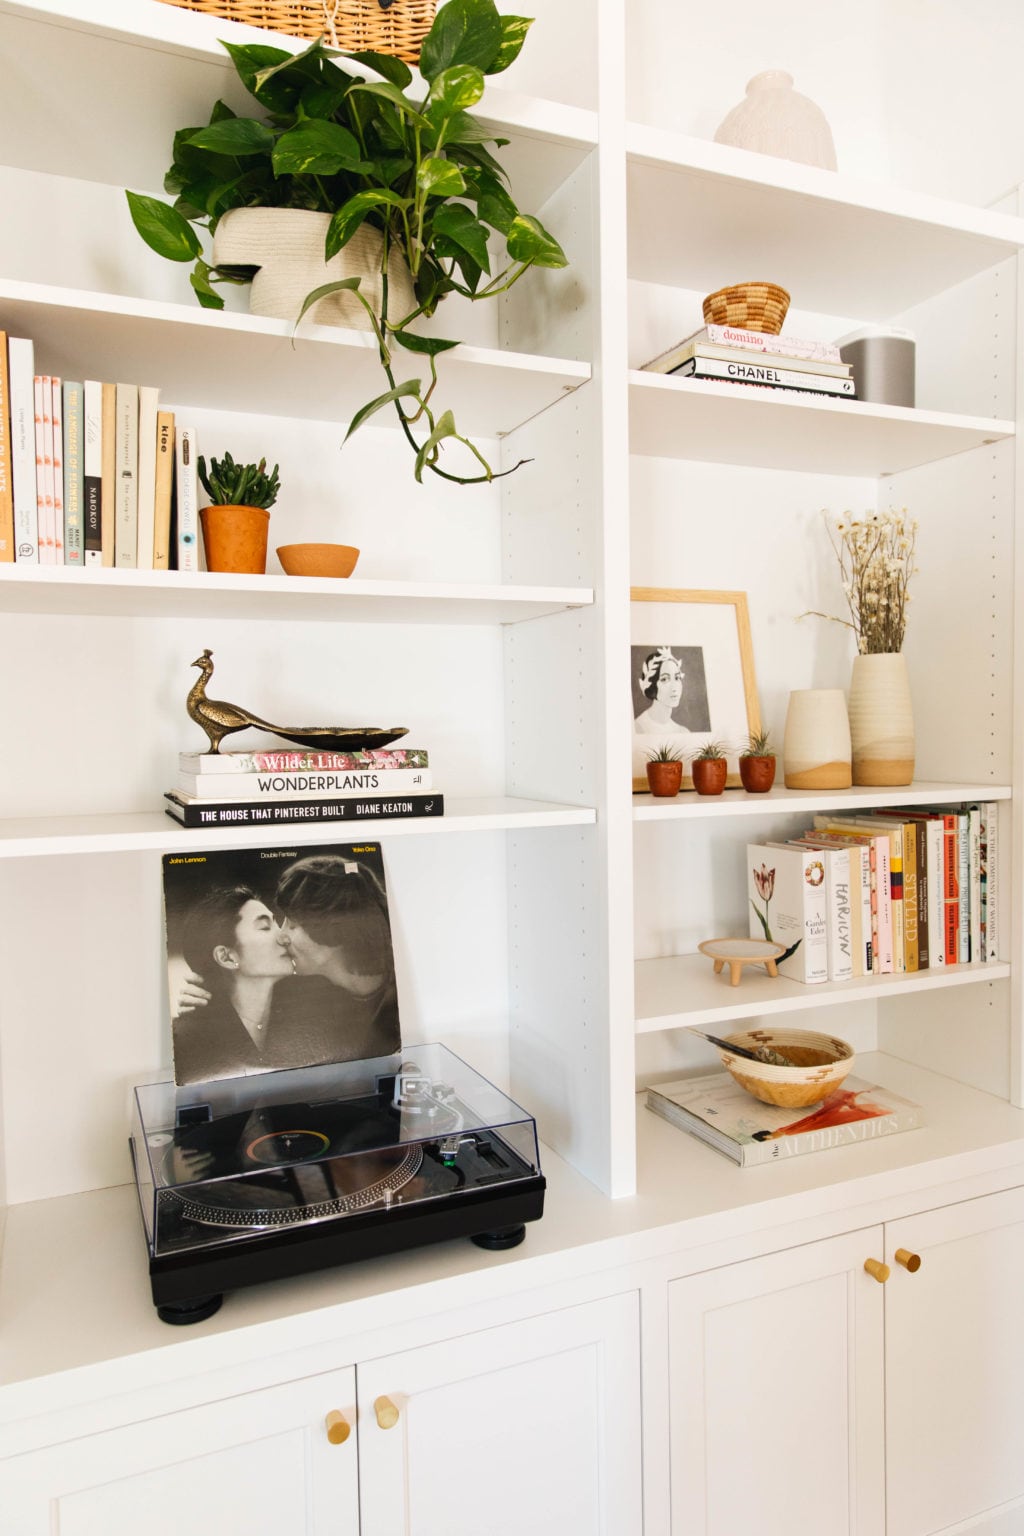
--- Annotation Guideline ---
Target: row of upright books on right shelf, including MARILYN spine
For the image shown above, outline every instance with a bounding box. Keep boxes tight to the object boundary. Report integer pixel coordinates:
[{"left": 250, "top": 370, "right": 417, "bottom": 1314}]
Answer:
[{"left": 746, "top": 800, "right": 999, "bottom": 982}]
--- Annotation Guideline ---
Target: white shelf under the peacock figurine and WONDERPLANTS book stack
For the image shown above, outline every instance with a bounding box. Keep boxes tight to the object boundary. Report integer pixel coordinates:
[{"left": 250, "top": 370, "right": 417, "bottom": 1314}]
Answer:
[{"left": 0, "top": 796, "right": 597, "bottom": 859}]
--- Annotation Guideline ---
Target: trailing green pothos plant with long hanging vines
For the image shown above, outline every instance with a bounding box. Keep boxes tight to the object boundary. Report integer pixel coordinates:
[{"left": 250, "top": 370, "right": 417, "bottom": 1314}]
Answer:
[{"left": 127, "top": 0, "right": 567, "bottom": 484}]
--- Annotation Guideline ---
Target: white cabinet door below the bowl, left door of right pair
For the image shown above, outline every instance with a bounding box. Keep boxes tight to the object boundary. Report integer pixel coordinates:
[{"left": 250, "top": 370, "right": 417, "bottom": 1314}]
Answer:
[{"left": 669, "top": 1227, "right": 884, "bottom": 1536}]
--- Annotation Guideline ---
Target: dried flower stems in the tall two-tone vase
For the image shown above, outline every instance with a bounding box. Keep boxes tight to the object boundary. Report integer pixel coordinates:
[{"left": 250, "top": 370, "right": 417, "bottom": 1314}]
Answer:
[{"left": 801, "top": 507, "right": 918, "bottom": 656}]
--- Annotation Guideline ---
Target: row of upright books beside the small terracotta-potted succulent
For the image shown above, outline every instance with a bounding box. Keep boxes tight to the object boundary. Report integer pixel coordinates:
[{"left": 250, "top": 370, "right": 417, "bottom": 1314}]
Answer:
[{"left": 0, "top": 330, "right": 200, "bottom": 571}]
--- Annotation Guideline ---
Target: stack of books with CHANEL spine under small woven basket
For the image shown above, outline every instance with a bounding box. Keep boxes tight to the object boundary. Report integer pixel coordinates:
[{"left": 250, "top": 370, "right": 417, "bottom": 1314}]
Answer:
[{"left": 643, "top": 326, "right": 857, "bottom": 399}]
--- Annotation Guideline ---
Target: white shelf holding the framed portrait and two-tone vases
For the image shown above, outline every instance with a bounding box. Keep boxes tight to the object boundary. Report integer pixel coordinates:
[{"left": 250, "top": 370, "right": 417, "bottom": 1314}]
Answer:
[{"left": 633, "top": 786, "right": 1012, "bottom": 822}]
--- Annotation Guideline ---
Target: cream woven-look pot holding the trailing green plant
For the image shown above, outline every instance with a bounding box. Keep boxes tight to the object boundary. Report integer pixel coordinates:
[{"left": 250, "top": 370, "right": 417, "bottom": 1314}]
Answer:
[{"left": 213, "top": 207, "right": 416, "bottom": 330}]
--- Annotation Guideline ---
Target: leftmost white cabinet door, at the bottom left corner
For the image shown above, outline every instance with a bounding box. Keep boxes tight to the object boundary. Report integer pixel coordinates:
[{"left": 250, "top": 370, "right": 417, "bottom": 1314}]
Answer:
[{"left": 0, "top": 1369, "right": 359, "bottom": 1536}]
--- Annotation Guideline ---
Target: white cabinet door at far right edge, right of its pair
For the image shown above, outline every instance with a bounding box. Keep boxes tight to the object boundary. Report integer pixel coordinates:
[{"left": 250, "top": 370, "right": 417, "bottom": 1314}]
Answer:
[{"left": 886, "top": 1189, "right": 1024, "bottom": 1536}]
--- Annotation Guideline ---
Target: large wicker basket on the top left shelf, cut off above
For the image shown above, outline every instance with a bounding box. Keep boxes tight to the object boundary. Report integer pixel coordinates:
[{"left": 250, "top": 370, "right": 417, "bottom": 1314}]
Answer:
[{"left": 164, "top": 0, "right": 438, "bottom": 65}]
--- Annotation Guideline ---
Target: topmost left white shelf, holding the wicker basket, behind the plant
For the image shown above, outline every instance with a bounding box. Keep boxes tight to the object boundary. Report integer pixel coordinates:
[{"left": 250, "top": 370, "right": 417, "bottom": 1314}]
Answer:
[{"left": 0, "top": 0, "right": 597, "bottom": 214}]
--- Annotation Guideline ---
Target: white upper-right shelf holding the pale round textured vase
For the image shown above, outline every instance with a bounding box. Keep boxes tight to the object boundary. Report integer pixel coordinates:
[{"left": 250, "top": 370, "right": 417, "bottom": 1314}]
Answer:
[{"left": 626, "top": 123, "right": 1024, "bottom": 321}]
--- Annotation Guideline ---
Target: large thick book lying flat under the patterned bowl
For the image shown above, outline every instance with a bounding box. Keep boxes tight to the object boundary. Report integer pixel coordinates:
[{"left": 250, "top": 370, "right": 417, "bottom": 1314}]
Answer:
[{"left": 646, "top": 1072, "right": 923, "bottom": 1167}]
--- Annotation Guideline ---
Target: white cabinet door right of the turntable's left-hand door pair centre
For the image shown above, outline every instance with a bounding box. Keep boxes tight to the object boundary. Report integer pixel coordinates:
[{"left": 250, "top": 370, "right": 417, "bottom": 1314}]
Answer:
[{"left": 358, "top": 1293, "right": 643, "bottom": 1536}]
